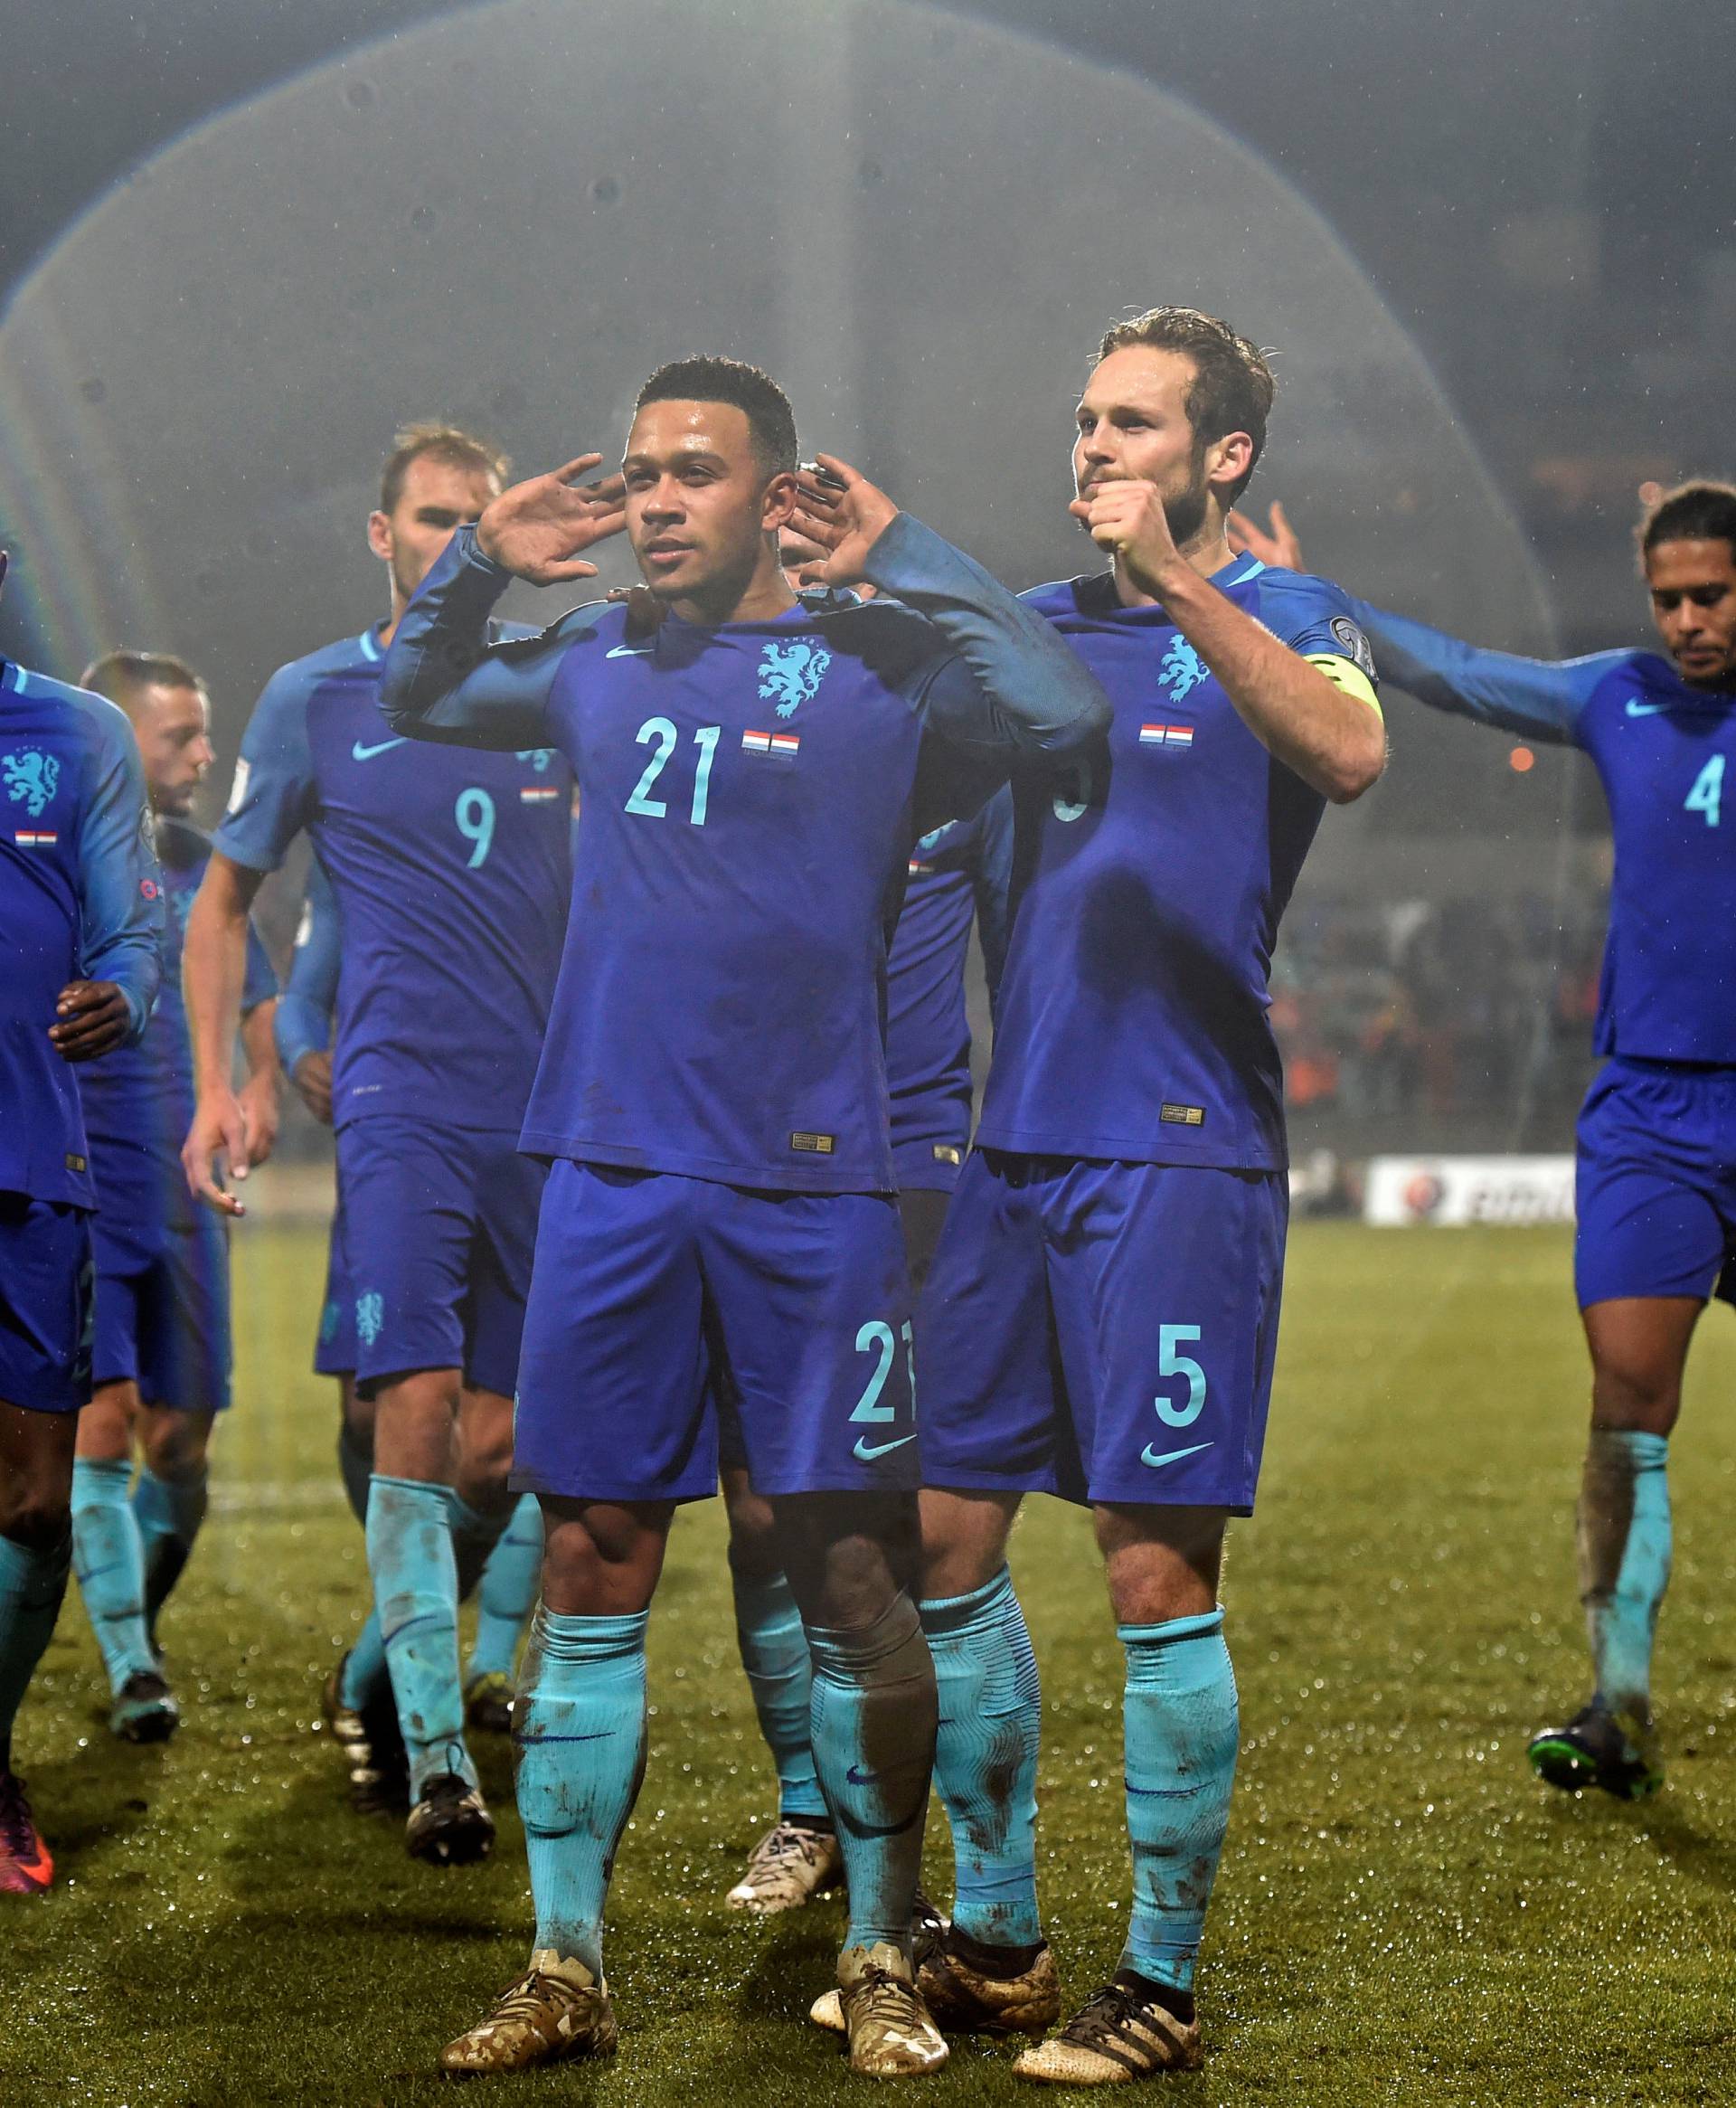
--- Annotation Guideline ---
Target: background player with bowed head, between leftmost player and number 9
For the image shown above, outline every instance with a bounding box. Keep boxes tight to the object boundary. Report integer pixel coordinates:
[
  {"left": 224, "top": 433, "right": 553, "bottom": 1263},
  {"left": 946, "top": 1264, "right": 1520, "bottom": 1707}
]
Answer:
[{"left": 71, "top": 651, "right": 278, "bottom": 1741}]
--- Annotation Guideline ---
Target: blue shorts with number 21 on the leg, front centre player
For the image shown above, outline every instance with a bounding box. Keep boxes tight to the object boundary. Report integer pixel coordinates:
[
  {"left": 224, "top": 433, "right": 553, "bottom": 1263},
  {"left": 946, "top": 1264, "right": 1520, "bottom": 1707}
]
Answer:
[{"left": 512, "top": 1158, "right": 919, "bottom": 1501}]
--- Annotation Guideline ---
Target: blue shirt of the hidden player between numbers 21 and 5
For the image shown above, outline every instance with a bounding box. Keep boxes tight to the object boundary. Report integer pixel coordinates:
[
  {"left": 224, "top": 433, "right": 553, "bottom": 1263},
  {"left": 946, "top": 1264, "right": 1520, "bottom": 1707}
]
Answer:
[{"left": 887, "top": 790, "right": 1014, "bottom": 1191}]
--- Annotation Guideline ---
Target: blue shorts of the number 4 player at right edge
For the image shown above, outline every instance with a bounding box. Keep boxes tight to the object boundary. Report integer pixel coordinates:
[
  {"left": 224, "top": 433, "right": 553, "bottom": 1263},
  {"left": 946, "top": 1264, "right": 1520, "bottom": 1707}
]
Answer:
[{"left": 1574, "top": 1060, "right": 1736, "bottom": 1309}]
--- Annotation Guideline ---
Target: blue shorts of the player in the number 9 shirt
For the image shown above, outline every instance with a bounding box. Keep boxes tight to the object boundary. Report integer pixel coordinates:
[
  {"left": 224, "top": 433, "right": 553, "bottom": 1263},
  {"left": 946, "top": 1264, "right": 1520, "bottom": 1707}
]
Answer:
[{"left": 337, "top": 1113, "right": 543, "bottom": 1397}]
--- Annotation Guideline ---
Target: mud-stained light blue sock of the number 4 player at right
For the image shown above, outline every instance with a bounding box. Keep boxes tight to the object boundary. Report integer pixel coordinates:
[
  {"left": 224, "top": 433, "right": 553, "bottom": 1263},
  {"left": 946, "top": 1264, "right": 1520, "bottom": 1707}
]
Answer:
[{"left": 1580, "top": 1427, "right": 1671, "bottom": 1725}]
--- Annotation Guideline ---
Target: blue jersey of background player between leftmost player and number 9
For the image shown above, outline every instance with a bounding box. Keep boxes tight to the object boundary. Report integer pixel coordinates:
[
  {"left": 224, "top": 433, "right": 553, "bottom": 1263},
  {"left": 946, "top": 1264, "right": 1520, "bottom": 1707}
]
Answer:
[{"left": 78, "top": 818, "right": 278, "bottom": 1221}]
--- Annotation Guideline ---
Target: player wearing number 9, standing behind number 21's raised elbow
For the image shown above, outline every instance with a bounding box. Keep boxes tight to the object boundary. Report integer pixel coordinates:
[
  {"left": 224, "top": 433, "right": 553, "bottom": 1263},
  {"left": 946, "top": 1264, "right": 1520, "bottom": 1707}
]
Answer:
[{"left": 184, "top": 426, "right": 571, "bottom": 1866}]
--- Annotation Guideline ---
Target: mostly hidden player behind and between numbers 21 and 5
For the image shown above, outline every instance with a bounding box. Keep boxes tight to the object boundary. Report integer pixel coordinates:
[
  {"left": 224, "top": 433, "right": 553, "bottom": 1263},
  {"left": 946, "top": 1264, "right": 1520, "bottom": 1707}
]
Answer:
[{"left": 722, "top": 775, "right": 1011, "bottom": 1912}]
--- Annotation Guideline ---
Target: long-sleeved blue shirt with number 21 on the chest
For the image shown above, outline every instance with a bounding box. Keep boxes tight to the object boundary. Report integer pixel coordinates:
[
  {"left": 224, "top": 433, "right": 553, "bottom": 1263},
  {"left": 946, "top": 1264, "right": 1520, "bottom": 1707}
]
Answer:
[{"left": 382, "top": 515, "right": 1109, "bottom": 1193}]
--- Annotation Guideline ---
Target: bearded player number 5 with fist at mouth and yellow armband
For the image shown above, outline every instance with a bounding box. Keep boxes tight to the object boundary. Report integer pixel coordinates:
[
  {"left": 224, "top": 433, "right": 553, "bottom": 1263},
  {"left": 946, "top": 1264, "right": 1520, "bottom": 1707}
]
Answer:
[{"left": 838, "top": 307, "right": 1384, "bottom": 2084}]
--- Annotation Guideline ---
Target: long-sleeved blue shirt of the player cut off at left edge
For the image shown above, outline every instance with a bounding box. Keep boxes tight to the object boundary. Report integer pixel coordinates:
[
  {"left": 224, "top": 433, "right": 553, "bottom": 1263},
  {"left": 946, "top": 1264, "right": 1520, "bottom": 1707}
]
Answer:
[{"left": 0, "top": 660, "right": 162, "bottom": 1208}]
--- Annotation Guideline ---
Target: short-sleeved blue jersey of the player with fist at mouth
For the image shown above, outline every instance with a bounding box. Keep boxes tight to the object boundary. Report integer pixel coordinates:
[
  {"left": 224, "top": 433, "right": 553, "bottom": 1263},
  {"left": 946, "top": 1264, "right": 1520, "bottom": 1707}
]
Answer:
[{"left": 977, "top": 556, "right": 1365, "bottom": 1170}]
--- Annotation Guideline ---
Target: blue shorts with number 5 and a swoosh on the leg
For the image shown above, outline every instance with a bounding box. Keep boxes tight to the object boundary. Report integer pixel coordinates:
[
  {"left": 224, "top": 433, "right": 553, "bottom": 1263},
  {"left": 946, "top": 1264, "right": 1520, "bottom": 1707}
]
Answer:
[{"left": 917, "top": 1149, "right": 1289, "bottom": 1516}]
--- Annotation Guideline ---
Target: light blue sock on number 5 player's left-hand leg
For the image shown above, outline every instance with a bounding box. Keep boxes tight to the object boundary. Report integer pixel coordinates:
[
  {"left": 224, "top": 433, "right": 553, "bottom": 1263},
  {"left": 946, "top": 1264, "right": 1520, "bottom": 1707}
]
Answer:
[{"left": 920, "top": 1566, "right": 1043, "bottom": 1948}]
